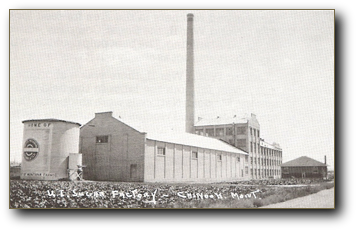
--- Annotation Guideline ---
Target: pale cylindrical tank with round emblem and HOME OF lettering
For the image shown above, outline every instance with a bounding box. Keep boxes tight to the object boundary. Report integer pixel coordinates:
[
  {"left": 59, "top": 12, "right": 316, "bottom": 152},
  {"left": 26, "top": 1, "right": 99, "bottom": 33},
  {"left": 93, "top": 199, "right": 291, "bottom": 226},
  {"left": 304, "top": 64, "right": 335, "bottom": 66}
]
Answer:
[{"left": 21, "top": 119, "right": 80, "bottom": 180}]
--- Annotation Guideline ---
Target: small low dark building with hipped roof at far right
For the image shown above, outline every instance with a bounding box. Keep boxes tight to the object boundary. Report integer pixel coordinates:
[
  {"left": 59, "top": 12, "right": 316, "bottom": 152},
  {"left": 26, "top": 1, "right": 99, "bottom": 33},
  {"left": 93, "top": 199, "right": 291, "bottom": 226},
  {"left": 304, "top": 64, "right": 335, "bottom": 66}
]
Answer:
[{"left": 281, "top": 156, "right": 327, "bottom": 179}]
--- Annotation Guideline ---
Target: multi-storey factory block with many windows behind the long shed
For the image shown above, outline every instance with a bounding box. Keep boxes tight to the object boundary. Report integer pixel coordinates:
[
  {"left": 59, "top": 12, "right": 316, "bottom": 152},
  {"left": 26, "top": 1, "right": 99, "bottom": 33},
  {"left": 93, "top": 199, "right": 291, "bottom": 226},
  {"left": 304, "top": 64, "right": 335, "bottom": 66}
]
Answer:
[{"left": 195, "top": 113, "right": 282, "bottom": 179}]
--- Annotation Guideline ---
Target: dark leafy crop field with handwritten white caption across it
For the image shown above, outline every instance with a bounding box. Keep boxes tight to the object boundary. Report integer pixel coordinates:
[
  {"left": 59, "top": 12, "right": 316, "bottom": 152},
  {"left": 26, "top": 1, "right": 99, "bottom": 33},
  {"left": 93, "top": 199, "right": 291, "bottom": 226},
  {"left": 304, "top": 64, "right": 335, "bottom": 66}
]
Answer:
[{"left": 10, "top": 180, "right": 334, "bottom": 208}]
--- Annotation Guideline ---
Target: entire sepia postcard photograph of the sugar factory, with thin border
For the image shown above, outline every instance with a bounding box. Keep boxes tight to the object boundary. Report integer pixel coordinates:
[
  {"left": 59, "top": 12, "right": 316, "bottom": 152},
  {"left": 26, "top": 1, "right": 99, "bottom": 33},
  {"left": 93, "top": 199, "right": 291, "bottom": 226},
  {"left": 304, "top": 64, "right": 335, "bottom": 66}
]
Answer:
[{"left": 9, "top": 9, "right": 335, "bottom": 209}]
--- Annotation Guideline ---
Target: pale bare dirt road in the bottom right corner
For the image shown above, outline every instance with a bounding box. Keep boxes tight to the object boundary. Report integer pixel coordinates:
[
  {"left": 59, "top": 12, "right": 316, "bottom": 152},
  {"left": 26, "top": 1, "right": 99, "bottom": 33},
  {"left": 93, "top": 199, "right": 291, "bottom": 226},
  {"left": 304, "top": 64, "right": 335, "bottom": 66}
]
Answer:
[{"left": 261, "top": 188, "right": 335, "bottom": 208}]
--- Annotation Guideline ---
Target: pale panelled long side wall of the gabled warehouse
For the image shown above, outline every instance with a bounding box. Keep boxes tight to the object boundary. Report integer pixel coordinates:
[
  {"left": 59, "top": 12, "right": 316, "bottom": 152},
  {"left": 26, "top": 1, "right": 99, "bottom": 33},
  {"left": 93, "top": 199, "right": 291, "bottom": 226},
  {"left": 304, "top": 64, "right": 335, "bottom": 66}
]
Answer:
[{"left": 144, "top": 140, "right": 247, "bottom": 182}]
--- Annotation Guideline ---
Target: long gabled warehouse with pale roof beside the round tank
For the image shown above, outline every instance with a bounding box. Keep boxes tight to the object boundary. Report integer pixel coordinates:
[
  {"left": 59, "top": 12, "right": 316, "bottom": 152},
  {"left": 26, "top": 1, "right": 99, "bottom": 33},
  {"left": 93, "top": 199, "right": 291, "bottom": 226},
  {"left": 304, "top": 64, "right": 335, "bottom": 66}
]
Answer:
[{"left": 80, "top": 112, "right": 249, "bottom": 182}]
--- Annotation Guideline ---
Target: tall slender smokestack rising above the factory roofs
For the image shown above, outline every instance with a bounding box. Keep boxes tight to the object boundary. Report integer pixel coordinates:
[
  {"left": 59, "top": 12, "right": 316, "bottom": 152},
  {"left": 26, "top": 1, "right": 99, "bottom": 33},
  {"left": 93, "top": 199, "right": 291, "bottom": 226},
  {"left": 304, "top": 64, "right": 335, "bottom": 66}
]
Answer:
[{"left": 185, "top": 14, "right": 194, "bottom": 133}]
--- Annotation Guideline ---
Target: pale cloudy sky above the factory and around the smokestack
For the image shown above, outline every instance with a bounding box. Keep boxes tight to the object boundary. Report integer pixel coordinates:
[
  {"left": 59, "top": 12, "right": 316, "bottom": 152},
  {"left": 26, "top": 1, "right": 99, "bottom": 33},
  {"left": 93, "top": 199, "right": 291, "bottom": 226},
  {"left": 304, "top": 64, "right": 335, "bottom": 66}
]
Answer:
[{"left": 10, "top": 10, "right": 335, "bottom": 169}]
